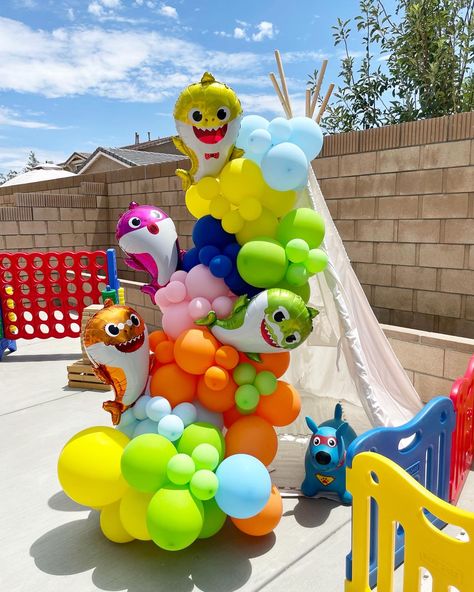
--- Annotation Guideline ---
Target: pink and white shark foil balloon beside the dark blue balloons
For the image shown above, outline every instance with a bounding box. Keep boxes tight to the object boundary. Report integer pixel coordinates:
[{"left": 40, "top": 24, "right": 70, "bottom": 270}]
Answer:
[{"left": 115, "top": 201, "right": 180, "bottom": 303}]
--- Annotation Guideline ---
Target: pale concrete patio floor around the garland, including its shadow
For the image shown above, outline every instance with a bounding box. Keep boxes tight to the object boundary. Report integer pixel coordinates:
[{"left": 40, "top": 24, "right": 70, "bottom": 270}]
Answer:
[{"left": 0, "top": 339, "right": 474, "bottom": 592}]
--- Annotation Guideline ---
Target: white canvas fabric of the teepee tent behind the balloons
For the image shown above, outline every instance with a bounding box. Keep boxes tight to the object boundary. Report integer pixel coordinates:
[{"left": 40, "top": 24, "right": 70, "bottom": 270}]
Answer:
[{"left": 281, "top": 167, "right": 422, "bottom": 434}]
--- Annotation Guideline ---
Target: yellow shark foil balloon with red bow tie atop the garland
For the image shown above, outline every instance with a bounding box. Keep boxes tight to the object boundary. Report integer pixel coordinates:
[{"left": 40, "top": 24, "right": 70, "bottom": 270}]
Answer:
[{"left": 173, "top": 72, "right": 242, "bottom": 191}]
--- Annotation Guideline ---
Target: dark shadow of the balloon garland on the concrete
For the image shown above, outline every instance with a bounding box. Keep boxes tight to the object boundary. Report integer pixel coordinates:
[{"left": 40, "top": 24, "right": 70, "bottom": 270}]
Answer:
[{"left": 30, "top": 512, "right": 276, "bottom": 592}]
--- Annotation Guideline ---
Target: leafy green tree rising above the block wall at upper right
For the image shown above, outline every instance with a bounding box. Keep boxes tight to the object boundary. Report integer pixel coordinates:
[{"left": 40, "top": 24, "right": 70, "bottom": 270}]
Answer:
[{"left": 308, "top": 0, "right": 474, "bottom": 132}]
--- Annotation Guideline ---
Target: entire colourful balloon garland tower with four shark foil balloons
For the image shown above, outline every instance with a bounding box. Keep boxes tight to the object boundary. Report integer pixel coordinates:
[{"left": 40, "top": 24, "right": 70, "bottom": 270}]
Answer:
[{"left": 58, "top": 73, "right": 327, "bottom": 551}]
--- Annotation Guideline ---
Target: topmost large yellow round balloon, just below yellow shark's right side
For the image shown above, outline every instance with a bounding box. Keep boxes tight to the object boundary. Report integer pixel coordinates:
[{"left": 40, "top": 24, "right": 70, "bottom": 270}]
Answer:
[{"left": 219, "top": 158, "right": 264, "bottom": 204}]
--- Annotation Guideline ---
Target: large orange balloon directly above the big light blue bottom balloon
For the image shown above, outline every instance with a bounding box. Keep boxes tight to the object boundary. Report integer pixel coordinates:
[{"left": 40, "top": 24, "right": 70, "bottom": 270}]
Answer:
[{"left": 225, "top": 415, "right": 278, "bottom": 465}]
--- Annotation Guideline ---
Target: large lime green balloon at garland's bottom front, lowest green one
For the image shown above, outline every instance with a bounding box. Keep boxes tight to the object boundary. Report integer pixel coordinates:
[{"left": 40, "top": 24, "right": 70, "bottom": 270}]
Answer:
[{"left": 147, "top": 484, "right": 204, "bottom": 551}]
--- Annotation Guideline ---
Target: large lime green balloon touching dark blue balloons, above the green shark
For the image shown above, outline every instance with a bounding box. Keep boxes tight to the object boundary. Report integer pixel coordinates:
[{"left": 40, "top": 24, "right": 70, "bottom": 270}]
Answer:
[{"left": 237, "top": 238, "right": 288, "bottom": 288}]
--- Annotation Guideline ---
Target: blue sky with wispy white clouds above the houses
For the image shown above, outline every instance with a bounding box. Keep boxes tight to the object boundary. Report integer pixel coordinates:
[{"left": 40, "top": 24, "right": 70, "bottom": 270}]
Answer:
[{"left": 0, "top": 0, "right": 393, "bottom": 172}]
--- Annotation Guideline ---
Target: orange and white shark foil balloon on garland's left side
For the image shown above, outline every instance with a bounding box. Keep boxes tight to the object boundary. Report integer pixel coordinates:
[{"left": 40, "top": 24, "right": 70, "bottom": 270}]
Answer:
[{"left": 83, "top": 299, "right": 151, "bottom": 425}]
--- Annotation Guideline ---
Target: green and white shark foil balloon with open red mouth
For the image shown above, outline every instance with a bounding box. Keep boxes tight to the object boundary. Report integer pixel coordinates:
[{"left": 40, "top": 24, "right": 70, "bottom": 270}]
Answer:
[{"left": 196, "top": 288, "right": 318, "bottom": 359}]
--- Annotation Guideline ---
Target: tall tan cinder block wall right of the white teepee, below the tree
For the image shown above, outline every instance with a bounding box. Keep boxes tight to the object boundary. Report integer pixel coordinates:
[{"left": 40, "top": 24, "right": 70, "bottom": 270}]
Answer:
[{"left": 314, "top": 113, "right": 474, "bottom": 337}]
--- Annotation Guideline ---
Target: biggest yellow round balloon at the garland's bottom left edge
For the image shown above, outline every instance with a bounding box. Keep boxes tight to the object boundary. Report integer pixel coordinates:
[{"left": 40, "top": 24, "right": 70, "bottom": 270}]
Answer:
[{"left": 58, "top": 426, "right": 130, "bottom": 508}]
